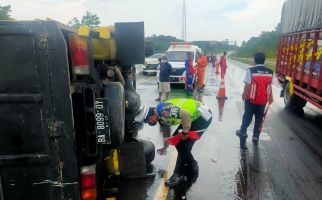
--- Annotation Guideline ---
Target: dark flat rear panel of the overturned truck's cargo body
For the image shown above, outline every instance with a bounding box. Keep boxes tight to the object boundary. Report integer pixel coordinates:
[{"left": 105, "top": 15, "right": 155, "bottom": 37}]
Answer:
[{"left": 0, "top": 21, "right": 79, "bottom": 200}]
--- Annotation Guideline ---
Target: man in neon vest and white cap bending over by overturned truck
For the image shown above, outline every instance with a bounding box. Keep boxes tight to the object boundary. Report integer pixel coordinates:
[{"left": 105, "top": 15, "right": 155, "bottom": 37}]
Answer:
[{"left": 136, "top": 99, "right": 212, "bottom": 187}]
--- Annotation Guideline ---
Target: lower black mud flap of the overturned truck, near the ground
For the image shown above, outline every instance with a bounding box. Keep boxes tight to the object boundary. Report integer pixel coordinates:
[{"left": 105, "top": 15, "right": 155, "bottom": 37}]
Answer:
[{"left": 118, "top": 142, "right": 147, "bottom": 178}]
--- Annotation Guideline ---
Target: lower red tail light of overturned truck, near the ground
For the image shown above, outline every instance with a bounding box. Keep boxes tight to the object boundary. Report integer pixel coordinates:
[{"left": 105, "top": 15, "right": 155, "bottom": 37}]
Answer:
[{"left": 80, "top": 165, "right": 97, "bottom": 200}]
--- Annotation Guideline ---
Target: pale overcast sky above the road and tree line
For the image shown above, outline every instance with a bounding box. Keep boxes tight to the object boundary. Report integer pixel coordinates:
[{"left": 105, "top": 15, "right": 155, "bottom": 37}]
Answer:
[{"left": 0, "top": 0, "right": 285, "bottom": 44}]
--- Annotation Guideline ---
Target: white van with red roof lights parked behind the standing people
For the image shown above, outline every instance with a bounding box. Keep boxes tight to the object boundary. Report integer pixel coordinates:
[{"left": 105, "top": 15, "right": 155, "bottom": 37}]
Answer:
[{"left": 165, "top": 42, "right": 201, "bottom": 83}]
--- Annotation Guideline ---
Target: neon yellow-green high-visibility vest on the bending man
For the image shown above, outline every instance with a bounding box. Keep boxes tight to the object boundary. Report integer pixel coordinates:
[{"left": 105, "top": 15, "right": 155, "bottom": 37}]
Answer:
[{"left": 156, "top": 99, "right": 202, "bottom": 126}]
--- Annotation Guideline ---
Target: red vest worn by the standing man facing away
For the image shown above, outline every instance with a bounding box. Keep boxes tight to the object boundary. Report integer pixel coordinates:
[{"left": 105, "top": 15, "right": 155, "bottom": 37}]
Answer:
[{"left": 246, "top": 65, "right": 273, "bottom": 105}]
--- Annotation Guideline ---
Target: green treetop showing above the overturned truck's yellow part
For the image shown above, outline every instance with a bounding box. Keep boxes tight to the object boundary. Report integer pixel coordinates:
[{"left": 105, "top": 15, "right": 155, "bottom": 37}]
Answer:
[{"left": 67, "top": 11, "right": 101, "bottom": 27}]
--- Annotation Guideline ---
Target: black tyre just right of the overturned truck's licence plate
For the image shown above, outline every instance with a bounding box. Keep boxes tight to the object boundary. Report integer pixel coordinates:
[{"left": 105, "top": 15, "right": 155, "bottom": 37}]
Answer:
[{"left": 104, "top": 82, "right": 125, "bottom": 147}]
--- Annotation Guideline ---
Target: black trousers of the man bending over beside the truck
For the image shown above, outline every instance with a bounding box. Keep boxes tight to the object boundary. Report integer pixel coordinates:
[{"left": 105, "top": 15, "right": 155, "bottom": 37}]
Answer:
[{"left": 173, "top": 117, "right": 212, "bottom": 174}]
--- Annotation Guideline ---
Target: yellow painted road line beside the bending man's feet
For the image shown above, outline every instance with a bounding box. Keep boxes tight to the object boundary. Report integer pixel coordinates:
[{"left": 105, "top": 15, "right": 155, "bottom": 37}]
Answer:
[{"left": 153, "top": 152, "right": 177, "bottom": 200}]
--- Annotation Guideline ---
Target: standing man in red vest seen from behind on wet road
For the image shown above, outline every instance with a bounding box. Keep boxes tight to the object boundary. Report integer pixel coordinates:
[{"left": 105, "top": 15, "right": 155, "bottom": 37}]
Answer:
[{"left": 236, "top": 52, "right": 273, "bottom": 149}]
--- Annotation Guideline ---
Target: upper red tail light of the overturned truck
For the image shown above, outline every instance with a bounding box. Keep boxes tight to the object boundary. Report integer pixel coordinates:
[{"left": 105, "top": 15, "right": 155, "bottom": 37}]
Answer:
[{"left": 69, "top": 35, "right": 89, "bottom": 75}]
